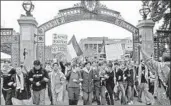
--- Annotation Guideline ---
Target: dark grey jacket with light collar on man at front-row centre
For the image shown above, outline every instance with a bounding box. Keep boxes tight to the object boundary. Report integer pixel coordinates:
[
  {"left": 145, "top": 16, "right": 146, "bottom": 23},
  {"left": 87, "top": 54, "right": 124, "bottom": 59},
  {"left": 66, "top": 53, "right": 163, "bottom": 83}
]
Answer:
[{"left": 81, "top": 68, "right": 94, "bottom": 93}]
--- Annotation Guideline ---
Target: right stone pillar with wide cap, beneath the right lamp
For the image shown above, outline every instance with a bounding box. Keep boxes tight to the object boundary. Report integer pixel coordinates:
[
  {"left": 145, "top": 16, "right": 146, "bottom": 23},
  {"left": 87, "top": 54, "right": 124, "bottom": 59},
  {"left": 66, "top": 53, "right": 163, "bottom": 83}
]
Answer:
[{"left": 137, "top": 20, "right": 155, "bottom": 56}]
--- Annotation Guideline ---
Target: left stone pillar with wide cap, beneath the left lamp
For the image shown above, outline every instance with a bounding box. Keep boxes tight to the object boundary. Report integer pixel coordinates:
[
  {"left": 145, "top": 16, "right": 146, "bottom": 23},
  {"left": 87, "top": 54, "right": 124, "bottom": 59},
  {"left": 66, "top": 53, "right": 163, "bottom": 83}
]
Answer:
[{"left": 18, "top": 15, "right": 38, "bottom": 70}]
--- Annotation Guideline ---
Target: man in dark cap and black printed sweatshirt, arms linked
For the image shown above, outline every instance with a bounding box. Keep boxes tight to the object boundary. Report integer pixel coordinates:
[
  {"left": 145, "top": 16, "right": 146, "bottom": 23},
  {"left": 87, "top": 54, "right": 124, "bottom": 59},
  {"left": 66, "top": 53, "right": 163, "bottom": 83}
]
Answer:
[{"left": 29, "top": 60, "right": 49, "bottom": 105}]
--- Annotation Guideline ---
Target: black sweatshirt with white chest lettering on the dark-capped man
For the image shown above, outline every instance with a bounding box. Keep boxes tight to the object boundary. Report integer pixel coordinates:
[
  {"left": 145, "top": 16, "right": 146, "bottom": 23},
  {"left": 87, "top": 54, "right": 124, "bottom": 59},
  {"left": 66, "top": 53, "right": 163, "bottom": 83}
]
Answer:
[{"left": 29, "top": 67, "right": 49, "bottom": 91}]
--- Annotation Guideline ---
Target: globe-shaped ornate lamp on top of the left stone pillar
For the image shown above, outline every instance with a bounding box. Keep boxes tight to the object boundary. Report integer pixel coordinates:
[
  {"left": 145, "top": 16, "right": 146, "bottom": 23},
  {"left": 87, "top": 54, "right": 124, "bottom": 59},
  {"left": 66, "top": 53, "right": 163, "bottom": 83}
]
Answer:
[{"left": 22, "top": 0, "right": 34, "bottom": 16}]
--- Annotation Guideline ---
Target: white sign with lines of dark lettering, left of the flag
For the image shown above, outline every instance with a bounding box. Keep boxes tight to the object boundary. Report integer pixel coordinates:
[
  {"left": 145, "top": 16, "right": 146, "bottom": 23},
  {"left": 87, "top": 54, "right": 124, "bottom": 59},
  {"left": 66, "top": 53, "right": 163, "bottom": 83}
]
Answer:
[{"left": 52, "top": 34, "right": 68, "bottom": 54}]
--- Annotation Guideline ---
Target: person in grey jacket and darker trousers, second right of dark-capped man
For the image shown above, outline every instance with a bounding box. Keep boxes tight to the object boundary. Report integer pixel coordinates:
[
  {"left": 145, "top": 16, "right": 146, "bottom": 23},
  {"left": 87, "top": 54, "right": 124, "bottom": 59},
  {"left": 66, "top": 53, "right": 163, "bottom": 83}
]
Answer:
[{"left": 66, "top": 64, "right": 82, "bottom": 105}]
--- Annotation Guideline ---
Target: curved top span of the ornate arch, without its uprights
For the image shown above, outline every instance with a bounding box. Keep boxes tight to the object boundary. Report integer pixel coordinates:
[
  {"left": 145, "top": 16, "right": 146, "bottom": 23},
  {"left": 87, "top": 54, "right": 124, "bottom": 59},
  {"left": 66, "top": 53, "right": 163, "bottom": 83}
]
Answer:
[{"left": 38, "top": 1, "right": 138, "bottom": 34}]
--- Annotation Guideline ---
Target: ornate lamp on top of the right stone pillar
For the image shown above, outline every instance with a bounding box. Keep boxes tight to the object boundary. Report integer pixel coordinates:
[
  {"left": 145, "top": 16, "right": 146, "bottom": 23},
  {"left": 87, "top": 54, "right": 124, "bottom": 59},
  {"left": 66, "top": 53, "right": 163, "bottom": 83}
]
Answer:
[{"left": 139, "top": 0, "right": 150, "bottom": 20}]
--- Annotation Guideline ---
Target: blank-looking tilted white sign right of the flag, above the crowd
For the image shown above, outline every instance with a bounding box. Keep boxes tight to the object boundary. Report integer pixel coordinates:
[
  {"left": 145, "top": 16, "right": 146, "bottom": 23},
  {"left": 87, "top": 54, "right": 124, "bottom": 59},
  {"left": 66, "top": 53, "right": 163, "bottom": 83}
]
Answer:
[{"left": 105, "top": 43, "right": 124, "bottom": 60}]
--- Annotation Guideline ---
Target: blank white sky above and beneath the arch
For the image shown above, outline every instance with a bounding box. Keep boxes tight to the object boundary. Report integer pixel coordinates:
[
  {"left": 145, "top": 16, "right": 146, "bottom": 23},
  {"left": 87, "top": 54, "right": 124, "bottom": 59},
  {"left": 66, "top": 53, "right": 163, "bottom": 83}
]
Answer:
[{"left": 1, "top": 1, "right": 162, "bottom": 45}]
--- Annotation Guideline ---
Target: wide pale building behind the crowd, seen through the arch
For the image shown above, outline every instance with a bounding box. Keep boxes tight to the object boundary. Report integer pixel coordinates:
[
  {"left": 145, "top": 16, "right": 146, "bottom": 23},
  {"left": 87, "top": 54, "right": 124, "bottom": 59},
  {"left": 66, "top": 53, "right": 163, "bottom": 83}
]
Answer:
[{"left": 79, "top": 37, "right": 133, "bottom": 58}]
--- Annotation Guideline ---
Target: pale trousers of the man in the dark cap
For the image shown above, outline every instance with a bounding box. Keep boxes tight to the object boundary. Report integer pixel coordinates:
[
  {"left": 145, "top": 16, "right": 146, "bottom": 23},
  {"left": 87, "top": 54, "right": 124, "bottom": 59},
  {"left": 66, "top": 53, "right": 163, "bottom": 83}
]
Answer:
[{"left": 33, "top": 89, "right": 45, "bottom": 105}]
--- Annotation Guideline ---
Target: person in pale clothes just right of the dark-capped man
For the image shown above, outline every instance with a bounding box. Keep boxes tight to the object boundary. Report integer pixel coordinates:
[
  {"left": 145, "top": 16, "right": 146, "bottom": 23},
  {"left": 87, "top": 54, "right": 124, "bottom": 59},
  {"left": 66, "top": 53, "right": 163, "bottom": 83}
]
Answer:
[{"left": 49, "top": 63, "right": 66, "bottom": 105}]
